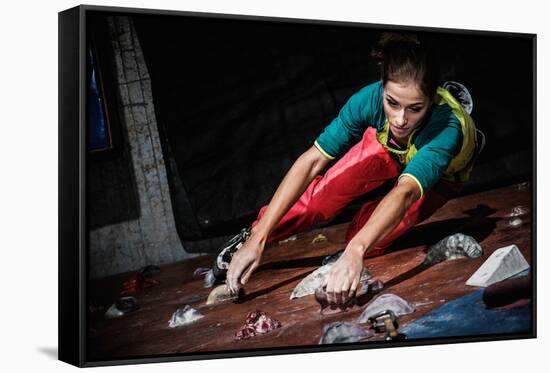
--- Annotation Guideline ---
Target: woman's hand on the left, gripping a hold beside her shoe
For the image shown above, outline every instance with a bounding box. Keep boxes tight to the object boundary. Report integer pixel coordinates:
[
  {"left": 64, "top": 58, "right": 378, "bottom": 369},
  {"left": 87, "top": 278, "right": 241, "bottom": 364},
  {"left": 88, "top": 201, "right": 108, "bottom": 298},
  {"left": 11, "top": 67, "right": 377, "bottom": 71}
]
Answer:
[{"left": 226, "top": 230, "right": 266, "bottom": 295}]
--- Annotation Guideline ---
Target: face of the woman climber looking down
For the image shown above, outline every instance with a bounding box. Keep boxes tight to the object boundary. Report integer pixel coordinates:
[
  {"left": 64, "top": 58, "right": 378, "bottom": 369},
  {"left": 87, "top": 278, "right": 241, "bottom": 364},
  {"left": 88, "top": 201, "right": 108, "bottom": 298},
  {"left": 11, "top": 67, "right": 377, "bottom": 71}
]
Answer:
[{"left": 384, "top": 80, "right": 431, "bottom": 142}]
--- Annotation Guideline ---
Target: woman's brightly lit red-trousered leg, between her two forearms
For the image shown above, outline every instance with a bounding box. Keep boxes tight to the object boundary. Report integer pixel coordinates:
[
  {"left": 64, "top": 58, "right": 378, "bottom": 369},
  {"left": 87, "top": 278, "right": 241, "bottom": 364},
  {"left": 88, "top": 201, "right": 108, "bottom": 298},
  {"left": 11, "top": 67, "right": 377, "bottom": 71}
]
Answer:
[{"left": 252, "top": 128, "right": 402, "bottom": 243}]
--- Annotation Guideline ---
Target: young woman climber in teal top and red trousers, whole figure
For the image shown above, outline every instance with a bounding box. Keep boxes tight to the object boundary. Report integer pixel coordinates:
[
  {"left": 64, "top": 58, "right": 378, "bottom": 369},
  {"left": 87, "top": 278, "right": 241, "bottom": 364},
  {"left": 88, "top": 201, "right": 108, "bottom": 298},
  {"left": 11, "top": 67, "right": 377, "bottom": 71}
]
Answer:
[{"left": 213, "top": 35, "right": 476, "bottom": 305}]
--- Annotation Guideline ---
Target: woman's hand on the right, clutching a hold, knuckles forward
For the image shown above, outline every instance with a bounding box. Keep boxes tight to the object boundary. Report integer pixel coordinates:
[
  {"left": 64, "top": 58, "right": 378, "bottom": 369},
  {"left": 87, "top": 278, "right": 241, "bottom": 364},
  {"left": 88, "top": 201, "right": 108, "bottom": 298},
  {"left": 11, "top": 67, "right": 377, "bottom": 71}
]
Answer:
[{"left": 325, "top": 247, "right": 363, "bottom": 306}]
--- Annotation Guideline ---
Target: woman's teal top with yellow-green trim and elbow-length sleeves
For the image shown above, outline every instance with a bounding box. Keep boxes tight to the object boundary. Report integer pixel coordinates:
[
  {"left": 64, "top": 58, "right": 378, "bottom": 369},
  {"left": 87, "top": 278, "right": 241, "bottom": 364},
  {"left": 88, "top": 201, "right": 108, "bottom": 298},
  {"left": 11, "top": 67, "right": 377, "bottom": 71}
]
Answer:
[{"left": 314, "top": 81, "right": 476, "bottom": 195}]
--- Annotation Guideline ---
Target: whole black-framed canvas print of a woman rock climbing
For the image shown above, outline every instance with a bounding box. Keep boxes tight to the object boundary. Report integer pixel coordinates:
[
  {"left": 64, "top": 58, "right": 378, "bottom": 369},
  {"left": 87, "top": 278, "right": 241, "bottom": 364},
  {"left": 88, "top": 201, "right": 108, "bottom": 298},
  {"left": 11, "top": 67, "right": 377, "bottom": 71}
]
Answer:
[{"left": 59, "top": 6, "right": 537, "bottom": 366}]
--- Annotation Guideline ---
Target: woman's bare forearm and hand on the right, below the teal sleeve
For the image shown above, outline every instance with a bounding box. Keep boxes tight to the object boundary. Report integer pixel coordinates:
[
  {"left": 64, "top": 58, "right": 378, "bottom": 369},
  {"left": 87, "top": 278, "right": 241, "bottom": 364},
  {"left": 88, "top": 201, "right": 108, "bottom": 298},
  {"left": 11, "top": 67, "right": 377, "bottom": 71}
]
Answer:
[{"left": 326, "top": 176, "right": 420, "bottom": 304}]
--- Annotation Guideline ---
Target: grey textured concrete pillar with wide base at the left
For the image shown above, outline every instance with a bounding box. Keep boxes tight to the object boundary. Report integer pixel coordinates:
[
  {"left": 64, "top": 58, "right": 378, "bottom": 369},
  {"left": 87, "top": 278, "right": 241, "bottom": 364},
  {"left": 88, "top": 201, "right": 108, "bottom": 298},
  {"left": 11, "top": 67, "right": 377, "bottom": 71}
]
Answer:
[{"left": 89, "top": 17, "right": 195, "bottom": 278}]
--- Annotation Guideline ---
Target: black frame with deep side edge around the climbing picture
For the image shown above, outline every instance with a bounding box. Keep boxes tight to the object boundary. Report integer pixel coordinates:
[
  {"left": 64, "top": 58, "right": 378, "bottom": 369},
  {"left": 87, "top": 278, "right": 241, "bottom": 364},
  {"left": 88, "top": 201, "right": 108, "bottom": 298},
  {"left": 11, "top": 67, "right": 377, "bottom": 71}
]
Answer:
[{"left": 58, "top": 5, "right": 537, "bottom": 367}]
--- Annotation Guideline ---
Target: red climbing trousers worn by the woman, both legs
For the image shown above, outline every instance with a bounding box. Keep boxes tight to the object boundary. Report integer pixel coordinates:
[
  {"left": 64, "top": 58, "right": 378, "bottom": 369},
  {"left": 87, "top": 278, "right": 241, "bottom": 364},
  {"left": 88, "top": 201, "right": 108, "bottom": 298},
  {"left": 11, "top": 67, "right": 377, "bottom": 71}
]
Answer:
[{"left": 252, "top": 128, "right": 461, "bottom": 257}]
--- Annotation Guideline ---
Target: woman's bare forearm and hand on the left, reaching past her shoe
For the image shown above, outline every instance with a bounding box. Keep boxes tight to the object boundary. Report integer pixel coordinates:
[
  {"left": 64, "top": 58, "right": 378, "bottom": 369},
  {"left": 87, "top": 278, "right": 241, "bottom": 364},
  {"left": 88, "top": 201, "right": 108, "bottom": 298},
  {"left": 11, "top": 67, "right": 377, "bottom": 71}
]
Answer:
[{"left": 227, "top": 146, "right": 329, "bottom": 294}]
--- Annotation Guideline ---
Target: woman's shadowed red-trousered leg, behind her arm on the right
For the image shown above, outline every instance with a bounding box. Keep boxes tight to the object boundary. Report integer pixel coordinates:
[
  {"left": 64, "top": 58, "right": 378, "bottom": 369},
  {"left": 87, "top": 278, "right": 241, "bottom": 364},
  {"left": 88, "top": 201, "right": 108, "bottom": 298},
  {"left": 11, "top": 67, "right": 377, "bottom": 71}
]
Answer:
[{"left": 346, "top": 180, "right": 462, "bottom": 258}]
